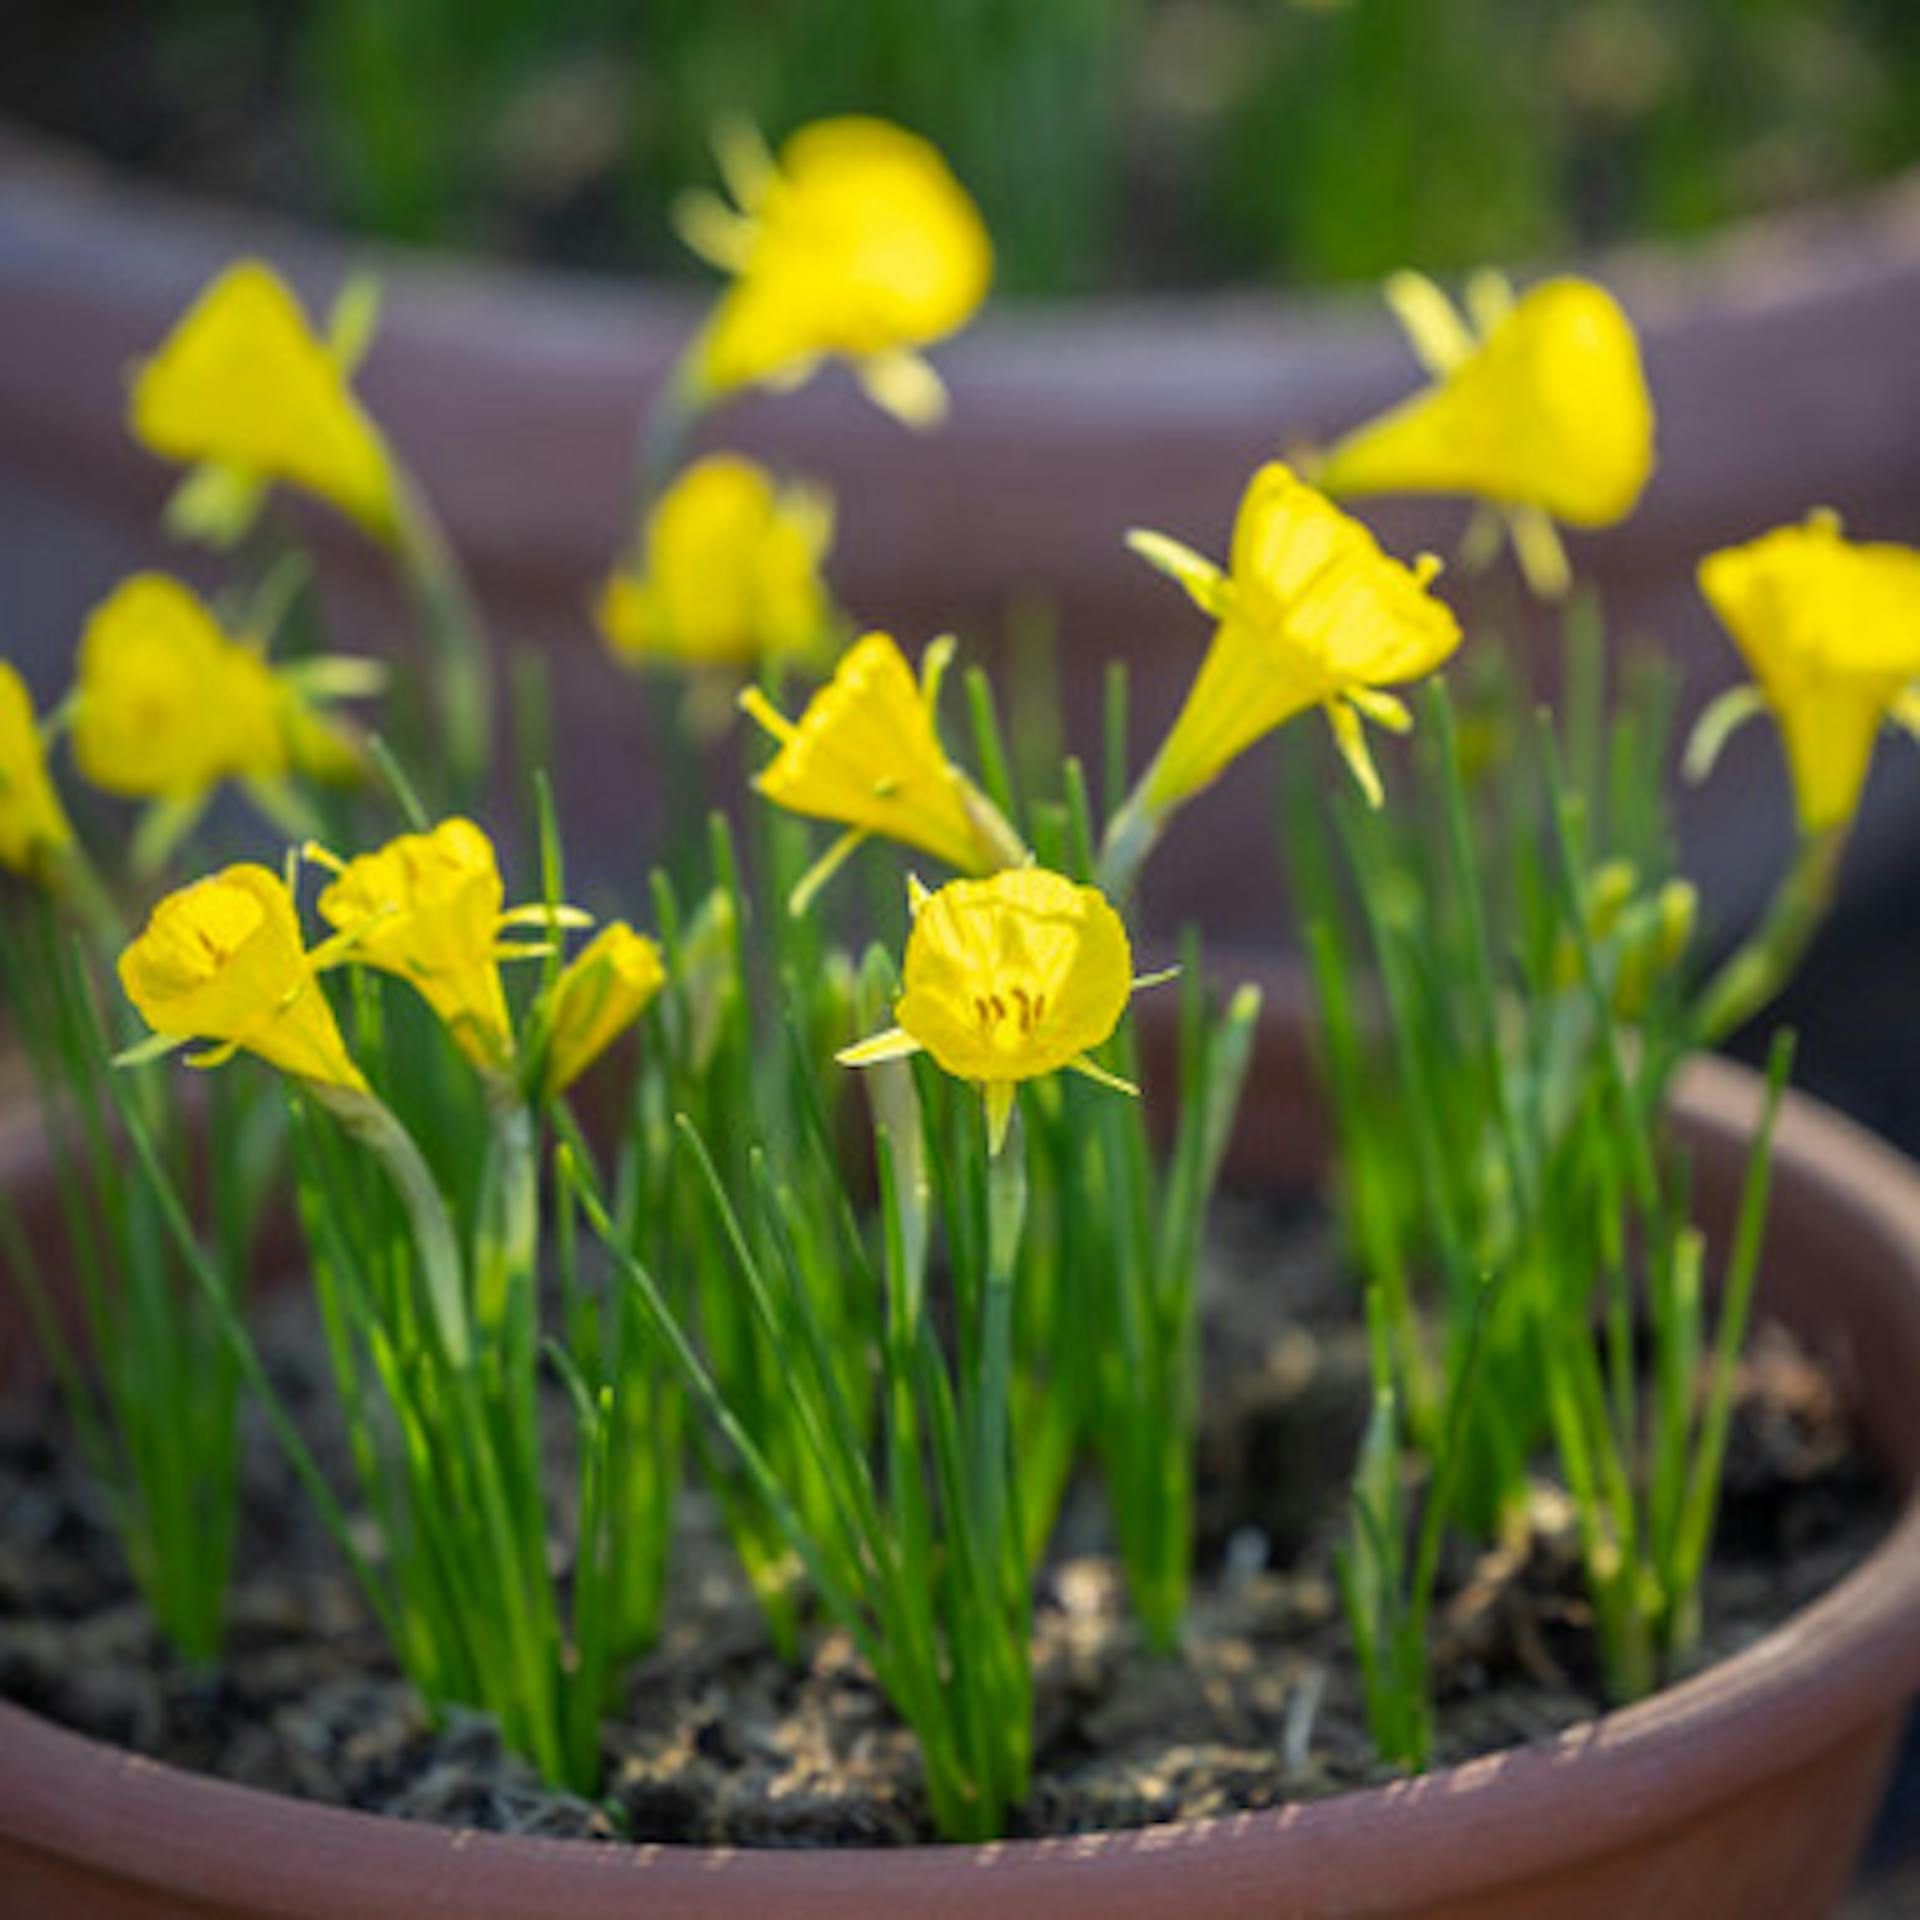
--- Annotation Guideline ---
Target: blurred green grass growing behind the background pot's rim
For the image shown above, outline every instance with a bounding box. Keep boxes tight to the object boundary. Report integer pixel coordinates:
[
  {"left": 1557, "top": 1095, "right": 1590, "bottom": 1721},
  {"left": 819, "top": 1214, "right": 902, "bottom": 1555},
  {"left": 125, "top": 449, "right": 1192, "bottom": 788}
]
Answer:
[{"left": 15, "top": 0, "right": 1920, "bottom": 292}]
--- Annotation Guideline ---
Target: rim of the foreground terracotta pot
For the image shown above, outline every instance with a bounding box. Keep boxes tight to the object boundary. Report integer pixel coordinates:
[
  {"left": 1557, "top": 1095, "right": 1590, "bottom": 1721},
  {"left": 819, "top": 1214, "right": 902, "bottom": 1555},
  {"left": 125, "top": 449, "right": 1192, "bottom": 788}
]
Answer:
[{"left": 0, "top": 990, "right": 1920, "bottom": 1920}]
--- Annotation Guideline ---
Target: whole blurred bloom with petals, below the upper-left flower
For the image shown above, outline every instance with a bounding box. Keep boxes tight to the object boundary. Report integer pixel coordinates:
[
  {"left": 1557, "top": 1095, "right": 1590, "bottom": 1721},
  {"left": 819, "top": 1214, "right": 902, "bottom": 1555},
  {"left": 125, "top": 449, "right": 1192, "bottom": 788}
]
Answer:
[{"left": 73, "top": 574, "right": 378, "bottom": 868}]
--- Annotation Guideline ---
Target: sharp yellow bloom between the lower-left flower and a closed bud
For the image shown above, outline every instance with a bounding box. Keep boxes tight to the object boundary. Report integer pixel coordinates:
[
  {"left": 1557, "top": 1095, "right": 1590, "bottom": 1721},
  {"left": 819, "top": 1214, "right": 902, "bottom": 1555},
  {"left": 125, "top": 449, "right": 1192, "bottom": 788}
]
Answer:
[{"left": 303, "top": 818, "right": 588, "bottom": 1075}]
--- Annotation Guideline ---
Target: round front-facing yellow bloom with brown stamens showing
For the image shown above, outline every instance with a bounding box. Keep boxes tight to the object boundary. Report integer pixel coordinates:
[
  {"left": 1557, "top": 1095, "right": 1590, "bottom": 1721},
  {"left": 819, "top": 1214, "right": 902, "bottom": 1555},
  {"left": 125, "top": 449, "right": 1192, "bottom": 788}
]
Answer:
[{"left": 837, "top": 866, "right": 1135, "bottom": 1152}]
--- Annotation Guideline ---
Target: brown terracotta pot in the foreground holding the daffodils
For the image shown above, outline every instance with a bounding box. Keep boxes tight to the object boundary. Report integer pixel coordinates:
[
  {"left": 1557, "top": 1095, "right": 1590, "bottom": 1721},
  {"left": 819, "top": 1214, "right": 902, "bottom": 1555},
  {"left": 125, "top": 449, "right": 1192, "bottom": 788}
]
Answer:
[{"left": 0, "top": 983, "right": 1920, "bottom": 1920}]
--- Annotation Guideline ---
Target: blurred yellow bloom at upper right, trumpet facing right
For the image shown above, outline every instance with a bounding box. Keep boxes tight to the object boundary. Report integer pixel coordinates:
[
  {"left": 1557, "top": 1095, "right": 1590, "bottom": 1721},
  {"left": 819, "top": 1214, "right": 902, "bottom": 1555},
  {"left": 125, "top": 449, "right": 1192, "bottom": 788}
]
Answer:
[{"left": 1313, "top": 273, "right": 1653, "bottom": 595}]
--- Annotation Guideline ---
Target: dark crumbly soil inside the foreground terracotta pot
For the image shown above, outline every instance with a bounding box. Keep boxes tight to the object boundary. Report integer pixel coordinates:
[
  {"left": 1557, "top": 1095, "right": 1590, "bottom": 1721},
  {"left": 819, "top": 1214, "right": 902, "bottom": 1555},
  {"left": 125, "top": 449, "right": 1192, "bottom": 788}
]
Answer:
[{"left": 0, "top": 1208, "right": 1893, "bottom": 1847}]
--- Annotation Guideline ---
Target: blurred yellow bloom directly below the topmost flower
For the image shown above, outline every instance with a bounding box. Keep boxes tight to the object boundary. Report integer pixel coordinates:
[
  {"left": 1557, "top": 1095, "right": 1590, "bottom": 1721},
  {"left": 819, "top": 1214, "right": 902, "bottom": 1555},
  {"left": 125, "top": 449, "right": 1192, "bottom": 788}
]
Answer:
[{"left": 597, "top": 453, "right": 833, "bottom": 668}]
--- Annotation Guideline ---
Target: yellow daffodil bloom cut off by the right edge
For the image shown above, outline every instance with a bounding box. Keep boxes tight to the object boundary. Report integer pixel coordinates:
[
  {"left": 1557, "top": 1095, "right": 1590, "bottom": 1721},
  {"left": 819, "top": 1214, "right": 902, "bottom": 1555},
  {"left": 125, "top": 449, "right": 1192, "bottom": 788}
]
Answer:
[{"left": 1690, "top": 515, "right": 1920, "bottom": 837}]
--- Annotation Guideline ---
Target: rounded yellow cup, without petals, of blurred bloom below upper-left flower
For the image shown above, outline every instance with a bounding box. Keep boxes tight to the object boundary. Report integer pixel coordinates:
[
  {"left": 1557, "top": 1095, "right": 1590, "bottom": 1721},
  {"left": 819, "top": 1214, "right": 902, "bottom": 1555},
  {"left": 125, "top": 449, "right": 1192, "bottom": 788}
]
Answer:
[{"left": 73, "top": 574, "right": 290, "bottom": 801}]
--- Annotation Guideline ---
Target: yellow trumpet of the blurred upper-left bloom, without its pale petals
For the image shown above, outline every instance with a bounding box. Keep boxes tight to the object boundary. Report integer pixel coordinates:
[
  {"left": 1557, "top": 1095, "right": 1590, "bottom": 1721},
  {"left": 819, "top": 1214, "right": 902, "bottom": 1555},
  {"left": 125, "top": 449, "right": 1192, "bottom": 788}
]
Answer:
[{"left": 131, "top": 259, "right": 396, "bottom": 540}]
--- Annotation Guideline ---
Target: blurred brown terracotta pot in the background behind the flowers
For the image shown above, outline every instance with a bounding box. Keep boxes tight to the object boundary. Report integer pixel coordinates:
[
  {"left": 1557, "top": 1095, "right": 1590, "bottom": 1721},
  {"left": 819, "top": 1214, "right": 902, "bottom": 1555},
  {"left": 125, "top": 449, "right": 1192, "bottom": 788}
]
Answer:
[{"left": 0, "top": 120, "right": 1920, "bottom": 943}]
